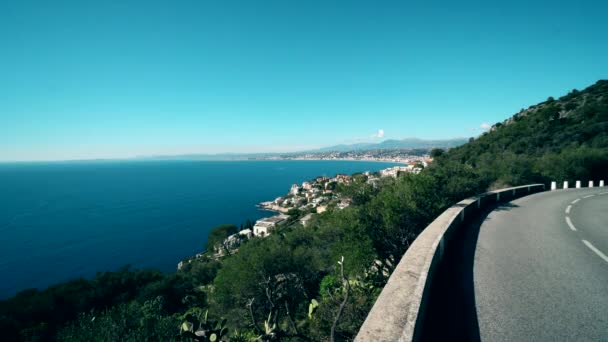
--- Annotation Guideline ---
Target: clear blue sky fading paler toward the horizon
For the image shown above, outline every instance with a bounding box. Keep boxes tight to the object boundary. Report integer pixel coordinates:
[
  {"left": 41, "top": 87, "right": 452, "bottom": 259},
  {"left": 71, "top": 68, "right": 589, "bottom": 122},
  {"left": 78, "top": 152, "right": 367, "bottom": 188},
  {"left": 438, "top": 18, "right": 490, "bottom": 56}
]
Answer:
[{"left": 0, "top": 0, "right": 608, "bottom": 160}]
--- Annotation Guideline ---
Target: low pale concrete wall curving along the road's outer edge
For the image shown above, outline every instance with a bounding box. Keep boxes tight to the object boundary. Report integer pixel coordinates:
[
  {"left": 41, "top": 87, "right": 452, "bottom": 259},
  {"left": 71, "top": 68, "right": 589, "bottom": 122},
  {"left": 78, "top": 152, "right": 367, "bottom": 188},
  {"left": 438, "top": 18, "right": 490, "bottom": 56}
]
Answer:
[{"left": 355, "top": 184, "right": 545, "bottom": 342}]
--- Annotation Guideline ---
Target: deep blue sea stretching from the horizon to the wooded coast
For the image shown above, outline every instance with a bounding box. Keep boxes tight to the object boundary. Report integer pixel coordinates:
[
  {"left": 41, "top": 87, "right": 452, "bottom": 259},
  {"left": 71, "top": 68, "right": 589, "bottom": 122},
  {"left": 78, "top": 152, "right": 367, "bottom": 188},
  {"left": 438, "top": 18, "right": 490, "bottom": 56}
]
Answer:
[{"left": 0, "top": 161, "right": 394, "bottom": 298}]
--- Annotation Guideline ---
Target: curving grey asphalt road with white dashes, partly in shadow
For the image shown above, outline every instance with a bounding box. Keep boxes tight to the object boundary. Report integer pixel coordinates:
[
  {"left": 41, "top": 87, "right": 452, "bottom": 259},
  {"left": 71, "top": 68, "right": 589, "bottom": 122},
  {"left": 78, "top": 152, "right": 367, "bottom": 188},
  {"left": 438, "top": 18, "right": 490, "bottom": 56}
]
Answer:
[{"left": 422, "top": 188, "right": 608, "bottom": 341}]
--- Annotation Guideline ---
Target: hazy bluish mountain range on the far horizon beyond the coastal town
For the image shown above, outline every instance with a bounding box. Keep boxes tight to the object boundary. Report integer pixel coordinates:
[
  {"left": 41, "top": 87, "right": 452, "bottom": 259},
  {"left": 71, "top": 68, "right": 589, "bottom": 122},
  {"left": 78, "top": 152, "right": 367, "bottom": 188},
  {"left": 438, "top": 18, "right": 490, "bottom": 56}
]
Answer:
[{"left": 307, "top": 138, "right": 468, "bottom": 152}]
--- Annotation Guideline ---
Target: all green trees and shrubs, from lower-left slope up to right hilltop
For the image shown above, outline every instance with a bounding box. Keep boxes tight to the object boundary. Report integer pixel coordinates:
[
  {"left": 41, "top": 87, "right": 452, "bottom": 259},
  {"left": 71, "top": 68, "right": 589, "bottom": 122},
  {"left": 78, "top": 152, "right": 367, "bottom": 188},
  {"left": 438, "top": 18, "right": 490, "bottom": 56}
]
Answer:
[{"left": 0, "top": 81, "right": 608, "bottom": 341}]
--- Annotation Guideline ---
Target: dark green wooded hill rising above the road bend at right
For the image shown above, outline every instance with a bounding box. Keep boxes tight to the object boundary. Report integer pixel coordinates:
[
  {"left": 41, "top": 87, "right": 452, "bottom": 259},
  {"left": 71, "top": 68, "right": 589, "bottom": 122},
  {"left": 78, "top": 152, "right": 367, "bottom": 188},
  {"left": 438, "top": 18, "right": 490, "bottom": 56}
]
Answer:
[{"left": 440, "top": 80, "right": 608, "bottom": 187}]
